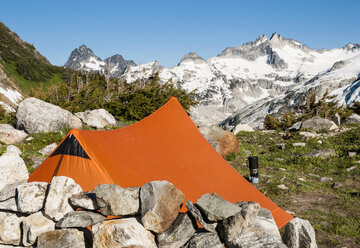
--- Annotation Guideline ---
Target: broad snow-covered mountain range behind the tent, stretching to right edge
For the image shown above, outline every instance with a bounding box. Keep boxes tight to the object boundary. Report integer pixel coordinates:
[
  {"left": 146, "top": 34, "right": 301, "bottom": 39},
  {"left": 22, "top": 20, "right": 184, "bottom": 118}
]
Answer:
[{"left": 122, "top": 33, "right": 360, "bottom": 128}]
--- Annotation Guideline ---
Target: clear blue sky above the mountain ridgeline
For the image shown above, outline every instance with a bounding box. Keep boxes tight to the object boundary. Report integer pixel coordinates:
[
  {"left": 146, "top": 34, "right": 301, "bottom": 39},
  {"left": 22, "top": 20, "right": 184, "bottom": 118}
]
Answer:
[{"left": 0, "top": 0, "right": 360, "bottom": 67}]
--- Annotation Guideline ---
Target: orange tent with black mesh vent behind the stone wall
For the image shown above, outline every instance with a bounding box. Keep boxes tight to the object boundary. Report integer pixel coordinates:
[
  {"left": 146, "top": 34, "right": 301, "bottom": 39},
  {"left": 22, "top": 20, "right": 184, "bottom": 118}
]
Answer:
[{"left": 29, "top": 97, "right": 293, "bottom": 228}]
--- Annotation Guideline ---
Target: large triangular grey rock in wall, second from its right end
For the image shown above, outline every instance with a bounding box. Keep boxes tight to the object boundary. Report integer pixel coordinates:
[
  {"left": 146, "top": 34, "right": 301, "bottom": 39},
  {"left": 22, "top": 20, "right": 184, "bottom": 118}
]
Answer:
[{"left": 227, "top": 208, "right": 286, "bottom": 248}]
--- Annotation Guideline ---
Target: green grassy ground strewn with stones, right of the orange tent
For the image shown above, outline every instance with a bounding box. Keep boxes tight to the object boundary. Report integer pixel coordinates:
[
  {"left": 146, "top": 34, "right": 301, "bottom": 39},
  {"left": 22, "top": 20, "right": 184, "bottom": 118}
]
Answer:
[{"left": 227, "top": 126, "right": 360, "bottom": 247}]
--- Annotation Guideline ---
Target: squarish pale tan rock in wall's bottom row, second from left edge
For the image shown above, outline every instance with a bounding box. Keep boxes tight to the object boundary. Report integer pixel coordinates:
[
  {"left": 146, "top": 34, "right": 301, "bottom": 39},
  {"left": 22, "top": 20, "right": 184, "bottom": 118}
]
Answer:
[{"left": 21, "top": 212, "right": 55, "bottom": 246}]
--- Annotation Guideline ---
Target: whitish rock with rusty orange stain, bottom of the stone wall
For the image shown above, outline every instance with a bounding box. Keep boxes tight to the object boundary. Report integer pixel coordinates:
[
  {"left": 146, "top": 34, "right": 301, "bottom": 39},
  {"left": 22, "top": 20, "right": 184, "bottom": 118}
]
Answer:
[{"left": 92, "top": 218, "right": 157, "bottom": 248}]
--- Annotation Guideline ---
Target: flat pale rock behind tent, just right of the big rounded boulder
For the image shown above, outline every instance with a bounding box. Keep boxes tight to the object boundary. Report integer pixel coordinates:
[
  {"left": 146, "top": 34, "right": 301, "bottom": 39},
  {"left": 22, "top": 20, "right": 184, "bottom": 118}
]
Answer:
[{"left": 75, "top": 109, "right": 117, "bottom": 128}]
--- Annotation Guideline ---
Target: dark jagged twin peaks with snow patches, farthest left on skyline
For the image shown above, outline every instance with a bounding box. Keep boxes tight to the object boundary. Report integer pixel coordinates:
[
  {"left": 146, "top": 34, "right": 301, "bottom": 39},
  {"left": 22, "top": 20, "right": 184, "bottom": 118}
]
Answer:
[{"left": 64, "top": 45, "right": 136, "bottom": 77}]
